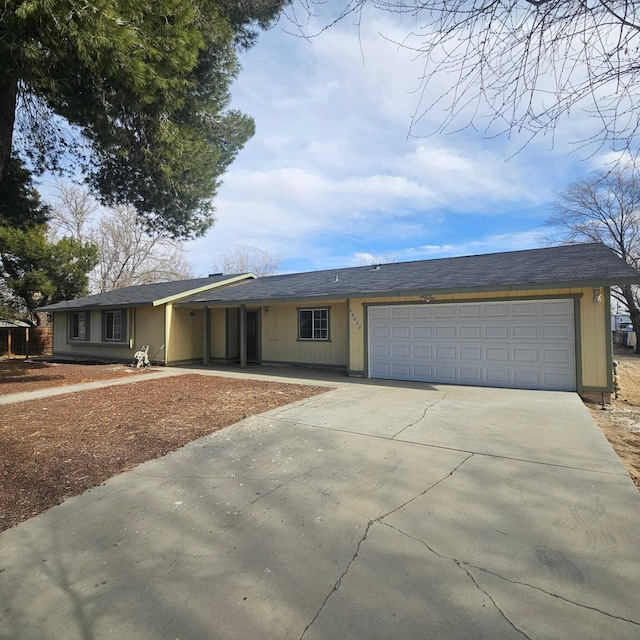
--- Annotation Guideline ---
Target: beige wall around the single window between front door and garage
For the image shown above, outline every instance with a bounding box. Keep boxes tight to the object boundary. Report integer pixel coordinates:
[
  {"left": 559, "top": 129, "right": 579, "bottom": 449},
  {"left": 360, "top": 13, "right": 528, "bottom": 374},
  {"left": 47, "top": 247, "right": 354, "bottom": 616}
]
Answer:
[{"left": 260, "top": 301, "right": 349, "bottom": 367}]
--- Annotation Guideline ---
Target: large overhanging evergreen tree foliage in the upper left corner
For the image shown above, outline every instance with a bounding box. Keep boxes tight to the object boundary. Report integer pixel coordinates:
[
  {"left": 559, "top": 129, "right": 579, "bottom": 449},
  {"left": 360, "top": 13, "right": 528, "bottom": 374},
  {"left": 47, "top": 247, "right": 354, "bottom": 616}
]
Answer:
[{"left": 0, "top": 0, "right": 282, "bottom": 238}]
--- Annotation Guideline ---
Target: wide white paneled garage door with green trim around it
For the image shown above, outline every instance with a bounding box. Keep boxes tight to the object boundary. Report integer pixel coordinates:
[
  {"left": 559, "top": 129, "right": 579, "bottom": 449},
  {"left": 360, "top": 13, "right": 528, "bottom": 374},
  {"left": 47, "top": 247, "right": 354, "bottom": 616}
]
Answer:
[{"left": 368, "top": 300, "right": 576, "bottom": 391}]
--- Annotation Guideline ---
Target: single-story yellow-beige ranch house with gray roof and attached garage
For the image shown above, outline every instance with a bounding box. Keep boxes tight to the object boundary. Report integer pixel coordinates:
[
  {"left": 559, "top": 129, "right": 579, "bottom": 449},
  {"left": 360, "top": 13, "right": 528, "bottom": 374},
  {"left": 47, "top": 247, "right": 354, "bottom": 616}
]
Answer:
[{"left": 38, "top": 244, "right": 640, "bottom": 395}]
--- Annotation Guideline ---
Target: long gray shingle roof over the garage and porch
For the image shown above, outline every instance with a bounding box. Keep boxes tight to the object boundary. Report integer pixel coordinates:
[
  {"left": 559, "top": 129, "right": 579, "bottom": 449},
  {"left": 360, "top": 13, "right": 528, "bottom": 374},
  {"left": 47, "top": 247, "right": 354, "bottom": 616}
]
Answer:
[{"left": 180, "top": 243, "right": 640, "bottom": 306}]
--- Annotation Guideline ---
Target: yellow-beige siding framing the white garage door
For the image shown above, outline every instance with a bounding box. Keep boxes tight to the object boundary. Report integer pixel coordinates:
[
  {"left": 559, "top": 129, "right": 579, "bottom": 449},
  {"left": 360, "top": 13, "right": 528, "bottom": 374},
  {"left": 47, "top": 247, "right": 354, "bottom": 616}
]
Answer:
[{"left": 349, "top": 288, "right": 611, "bottom": 389}]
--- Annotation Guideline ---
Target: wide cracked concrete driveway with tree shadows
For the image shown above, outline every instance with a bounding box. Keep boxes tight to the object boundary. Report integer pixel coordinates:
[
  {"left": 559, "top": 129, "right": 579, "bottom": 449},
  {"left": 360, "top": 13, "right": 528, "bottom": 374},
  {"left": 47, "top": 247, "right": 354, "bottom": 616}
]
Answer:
[{"left": 0, "top": 382, "right": 640, "bottom": 640}]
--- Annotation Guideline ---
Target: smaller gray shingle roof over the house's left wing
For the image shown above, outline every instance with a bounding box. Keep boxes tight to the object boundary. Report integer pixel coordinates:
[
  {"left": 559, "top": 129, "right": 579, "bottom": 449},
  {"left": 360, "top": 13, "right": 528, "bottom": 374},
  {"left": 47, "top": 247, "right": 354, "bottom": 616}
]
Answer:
[{"left": 38, "top": 274, "right": 248, "bottom": 311}]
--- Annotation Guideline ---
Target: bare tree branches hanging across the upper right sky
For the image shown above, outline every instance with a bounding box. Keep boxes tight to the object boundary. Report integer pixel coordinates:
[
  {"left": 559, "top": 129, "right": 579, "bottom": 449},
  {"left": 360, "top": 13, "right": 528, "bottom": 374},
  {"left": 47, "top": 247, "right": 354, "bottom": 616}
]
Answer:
[{"left": 296, "top": 0, "right": 640, "bottom": 150}]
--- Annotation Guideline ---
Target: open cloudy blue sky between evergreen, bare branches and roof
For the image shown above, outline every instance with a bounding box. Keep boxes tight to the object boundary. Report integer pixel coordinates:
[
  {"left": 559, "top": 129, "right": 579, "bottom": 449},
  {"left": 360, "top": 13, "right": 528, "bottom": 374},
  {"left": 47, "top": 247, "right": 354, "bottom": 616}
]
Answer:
[{"left": 182, "top": 13, "right": 607, "bottom": 275}]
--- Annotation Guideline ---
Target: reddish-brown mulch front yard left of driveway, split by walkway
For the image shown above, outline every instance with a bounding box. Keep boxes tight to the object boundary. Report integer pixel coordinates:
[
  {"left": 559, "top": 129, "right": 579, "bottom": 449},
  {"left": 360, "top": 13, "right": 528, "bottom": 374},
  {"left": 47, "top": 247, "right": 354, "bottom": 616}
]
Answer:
[{"left": 0, "top": 363, "right": 328, "bottom": 531}]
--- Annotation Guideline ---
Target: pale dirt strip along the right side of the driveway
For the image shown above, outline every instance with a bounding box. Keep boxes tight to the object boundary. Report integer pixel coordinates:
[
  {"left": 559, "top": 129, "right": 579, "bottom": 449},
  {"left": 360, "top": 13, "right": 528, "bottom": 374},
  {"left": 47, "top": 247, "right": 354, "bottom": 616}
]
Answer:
[{"left": 587, "top": 348, "right": 640, "bottom": 489}]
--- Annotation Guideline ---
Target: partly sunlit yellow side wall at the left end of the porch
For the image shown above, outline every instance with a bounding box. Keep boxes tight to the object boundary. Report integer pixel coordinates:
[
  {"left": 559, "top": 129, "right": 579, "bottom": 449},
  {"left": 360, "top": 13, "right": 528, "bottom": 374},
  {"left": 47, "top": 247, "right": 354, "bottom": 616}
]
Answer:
[{"left": 165, "top": 304, "right": 204, "bottom": 364}]
